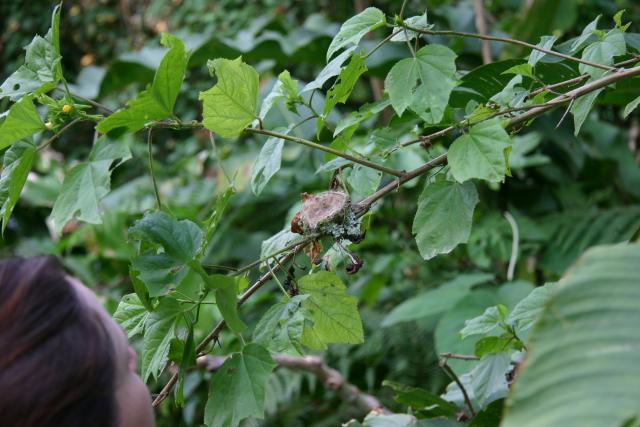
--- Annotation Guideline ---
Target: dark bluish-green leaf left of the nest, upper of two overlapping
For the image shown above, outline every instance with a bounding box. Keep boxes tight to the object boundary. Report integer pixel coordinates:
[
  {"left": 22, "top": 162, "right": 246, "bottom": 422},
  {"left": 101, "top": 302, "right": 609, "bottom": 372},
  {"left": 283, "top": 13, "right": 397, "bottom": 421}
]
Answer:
[{"left": 129, "top": 212, "right": 202, "bottom": 263}]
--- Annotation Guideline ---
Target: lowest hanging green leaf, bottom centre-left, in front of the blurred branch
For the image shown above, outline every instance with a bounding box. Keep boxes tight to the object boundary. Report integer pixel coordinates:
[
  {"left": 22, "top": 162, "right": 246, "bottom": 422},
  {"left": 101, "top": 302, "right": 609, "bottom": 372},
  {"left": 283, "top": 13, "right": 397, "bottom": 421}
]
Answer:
[{"left": 204, "top": 343, "right": 276, "bottom": 427}]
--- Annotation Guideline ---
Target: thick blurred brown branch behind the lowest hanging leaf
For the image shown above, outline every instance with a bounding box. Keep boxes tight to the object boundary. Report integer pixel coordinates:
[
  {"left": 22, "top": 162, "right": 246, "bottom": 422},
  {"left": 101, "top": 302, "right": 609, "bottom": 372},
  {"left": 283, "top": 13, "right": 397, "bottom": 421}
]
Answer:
[{"left": 198, "top": 354, "right": 387, "bottom": 412}]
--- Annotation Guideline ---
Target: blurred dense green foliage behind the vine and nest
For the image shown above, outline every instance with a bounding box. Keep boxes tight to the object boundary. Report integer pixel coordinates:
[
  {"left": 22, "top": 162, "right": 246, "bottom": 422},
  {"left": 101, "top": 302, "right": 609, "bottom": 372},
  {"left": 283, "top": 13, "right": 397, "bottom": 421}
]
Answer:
[{"left": 0, "top": 0, "right": 640, "bottom": 426}]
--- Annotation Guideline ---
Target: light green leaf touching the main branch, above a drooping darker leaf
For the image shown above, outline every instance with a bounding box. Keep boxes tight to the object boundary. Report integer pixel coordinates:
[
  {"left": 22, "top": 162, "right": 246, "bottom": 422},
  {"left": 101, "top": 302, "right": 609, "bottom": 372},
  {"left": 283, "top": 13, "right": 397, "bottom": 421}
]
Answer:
[{"left": 448, "top": 118, "right": 511, "bottom": 182}]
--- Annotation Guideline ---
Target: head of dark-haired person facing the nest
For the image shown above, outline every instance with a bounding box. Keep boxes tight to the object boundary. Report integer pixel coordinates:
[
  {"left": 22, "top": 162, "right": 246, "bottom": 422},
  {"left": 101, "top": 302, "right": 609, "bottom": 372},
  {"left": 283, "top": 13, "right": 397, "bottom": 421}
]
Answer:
[{"left": 0, "top": 257, "right": 153, "bottom": 427}]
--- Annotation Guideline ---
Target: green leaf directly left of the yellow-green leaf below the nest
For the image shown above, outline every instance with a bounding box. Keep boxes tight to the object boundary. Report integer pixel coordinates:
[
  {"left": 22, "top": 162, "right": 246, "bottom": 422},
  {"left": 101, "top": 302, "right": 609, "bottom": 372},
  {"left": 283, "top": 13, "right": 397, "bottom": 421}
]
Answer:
[{"left": 253, "top": 295, "right": 309, "bottom": 354}]
